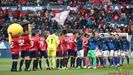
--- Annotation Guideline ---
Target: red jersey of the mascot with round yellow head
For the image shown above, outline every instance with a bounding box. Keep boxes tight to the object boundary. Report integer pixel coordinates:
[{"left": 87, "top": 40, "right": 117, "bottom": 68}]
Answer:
[{"left": 10, "top": 38, "right": 20, "bottom": 54}]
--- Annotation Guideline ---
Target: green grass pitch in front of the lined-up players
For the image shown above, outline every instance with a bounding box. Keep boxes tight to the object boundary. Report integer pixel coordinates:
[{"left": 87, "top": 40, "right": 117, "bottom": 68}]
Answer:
[{"left": 0, "top": 58, "right": 133, "bottom": 75}]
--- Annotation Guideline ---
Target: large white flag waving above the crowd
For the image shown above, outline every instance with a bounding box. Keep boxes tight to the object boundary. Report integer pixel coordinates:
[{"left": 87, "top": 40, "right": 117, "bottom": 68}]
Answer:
[{"left": 53, "top": 11, "right": 70, "bottom": 25}]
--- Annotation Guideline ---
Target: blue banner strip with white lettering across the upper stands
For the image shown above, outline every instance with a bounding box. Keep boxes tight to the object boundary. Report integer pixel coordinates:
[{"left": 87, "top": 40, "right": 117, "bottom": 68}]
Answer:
[{"left": 2, "top": 4, "right": 133, "bottom": 11}]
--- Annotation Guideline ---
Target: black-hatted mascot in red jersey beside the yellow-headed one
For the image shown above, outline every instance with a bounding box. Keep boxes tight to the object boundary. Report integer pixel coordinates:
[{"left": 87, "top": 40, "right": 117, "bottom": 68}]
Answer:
[{"left": 19, "top": 21, "right": 31, "bottom": 71}]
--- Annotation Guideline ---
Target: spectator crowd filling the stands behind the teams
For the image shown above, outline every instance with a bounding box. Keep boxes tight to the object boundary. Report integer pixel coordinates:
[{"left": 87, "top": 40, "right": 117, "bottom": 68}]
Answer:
[{"left": 0, "top": 0, "right": 133, "bottom": 40}]
